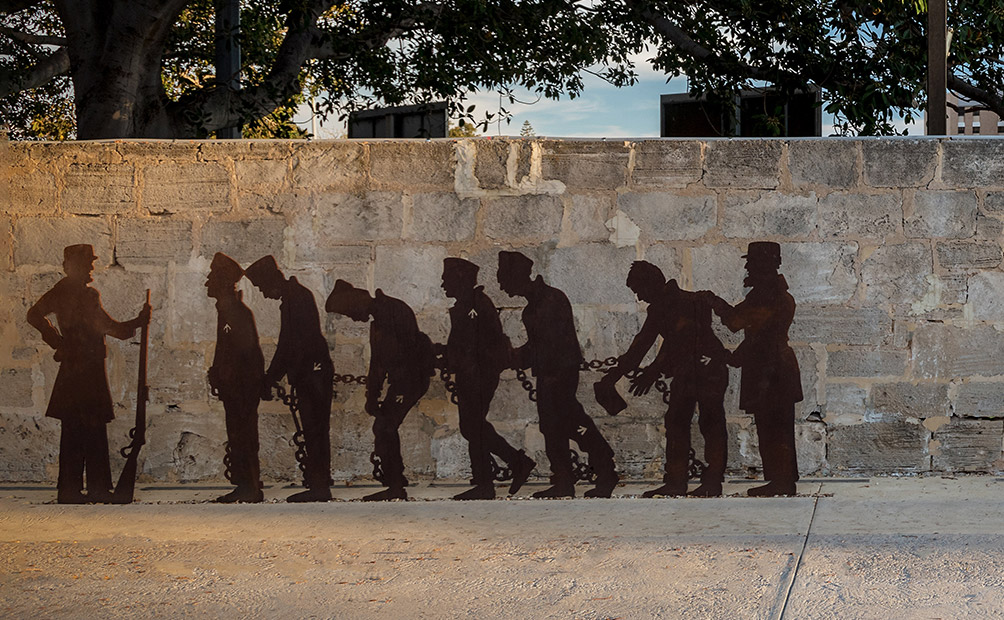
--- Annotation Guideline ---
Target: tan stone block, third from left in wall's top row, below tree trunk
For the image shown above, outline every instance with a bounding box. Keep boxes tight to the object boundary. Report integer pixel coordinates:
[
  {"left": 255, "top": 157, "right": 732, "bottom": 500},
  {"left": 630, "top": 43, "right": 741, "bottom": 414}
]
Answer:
[{"left": 141, "top": 162, "right": 231, "bottom": 214}]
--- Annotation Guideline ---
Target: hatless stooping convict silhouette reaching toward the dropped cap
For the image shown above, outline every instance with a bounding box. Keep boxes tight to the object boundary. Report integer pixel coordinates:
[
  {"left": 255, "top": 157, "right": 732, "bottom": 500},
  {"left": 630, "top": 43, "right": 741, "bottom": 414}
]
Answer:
[{"left": 599, "top": 261, "right": 729, "bottom": 498}]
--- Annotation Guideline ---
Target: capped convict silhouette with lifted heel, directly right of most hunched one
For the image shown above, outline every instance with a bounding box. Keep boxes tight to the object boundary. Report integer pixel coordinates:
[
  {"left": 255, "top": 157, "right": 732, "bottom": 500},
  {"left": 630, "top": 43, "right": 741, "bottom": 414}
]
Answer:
[{"left": 443, "top": 258, "right": 536, "bottom": 500}]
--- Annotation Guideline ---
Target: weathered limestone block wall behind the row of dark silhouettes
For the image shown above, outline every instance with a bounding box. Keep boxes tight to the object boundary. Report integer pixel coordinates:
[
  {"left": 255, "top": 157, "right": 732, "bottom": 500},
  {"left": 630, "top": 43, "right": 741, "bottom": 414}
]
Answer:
[{"left": 0, "top": 138, "right": 1004, "bottom": 481}]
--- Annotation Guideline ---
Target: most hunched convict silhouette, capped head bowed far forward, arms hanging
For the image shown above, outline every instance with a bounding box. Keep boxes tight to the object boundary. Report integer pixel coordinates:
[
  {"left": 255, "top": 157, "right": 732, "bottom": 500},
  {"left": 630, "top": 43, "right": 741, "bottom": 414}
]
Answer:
[{"left": 324, "top": 280, "right": 435, "bottom": 502}]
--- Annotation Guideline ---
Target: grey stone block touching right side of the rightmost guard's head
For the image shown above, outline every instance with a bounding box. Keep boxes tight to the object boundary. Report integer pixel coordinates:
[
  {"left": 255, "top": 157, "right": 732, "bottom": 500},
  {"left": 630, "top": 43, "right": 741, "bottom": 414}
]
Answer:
[{"left": 781, "top": 243, "right": 857, "bottom": 304}]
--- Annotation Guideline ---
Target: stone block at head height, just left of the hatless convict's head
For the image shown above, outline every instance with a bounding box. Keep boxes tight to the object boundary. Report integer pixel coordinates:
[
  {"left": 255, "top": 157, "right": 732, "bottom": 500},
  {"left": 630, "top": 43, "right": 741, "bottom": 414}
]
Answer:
[{"left": 544, "top": 244, "right": 636, "bottom": 305}]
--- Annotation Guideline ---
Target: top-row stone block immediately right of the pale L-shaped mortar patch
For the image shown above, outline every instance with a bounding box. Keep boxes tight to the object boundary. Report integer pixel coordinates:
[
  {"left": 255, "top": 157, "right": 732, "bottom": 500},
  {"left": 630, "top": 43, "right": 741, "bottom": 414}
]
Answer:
[{"left": 540, "top": 140, "right": 631, "bottom": 191}]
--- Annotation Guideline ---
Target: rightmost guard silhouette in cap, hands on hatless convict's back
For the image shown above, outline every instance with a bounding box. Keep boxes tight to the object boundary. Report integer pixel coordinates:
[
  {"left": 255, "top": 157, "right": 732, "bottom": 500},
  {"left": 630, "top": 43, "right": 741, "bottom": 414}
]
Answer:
[{"left": 709, "top": 241, "right": 802, "bottom": 497}]
